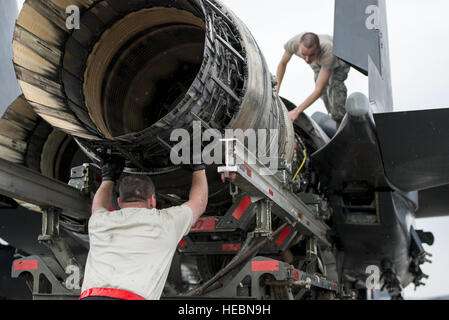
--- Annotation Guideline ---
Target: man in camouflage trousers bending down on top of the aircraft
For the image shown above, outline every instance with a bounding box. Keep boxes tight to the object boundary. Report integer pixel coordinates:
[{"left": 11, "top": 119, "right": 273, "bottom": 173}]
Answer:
[{"left": 276, "top": 32, "right": 350, "bottom": 124}]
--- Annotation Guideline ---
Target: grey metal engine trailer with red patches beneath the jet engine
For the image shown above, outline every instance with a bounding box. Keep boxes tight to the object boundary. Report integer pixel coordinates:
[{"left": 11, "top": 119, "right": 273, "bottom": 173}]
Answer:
[{"left": 0, "top": 139, "right": 344, "bottom": 300}]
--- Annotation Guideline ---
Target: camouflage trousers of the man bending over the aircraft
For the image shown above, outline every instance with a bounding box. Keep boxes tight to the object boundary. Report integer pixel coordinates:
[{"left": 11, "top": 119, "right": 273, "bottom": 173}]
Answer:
[{"left": 313, "top": 60, "right": 351, "bottom": 123}]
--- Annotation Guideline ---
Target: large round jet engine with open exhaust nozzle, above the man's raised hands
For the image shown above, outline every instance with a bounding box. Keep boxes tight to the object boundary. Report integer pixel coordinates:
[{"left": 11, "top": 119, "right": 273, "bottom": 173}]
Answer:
[{"left": 13, "top": 0, "right": 295, "bottom": 169}]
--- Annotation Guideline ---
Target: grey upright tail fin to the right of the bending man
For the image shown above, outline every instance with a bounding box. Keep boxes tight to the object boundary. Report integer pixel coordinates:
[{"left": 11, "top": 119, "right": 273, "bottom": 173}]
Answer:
[{"left": 334, "top": 0, "right": 393, "bottom": 113}]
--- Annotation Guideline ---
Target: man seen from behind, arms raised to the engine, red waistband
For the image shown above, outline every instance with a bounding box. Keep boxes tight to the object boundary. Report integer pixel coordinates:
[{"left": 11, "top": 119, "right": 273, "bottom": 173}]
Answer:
[{"left": 80, "top": 159, "right": 208, "bottom": 300}]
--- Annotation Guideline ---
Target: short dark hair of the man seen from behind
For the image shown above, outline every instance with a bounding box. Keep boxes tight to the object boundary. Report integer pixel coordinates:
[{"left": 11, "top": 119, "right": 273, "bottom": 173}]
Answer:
[{"left": 119, "top": 175, "right": 155, "bottom": 202}]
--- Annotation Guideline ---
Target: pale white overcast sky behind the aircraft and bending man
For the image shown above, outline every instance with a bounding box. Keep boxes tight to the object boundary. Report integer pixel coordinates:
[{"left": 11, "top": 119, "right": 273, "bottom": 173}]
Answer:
[{"left": 14, "top": 0, "right": 449, "bottom": 298}]
